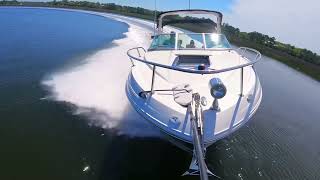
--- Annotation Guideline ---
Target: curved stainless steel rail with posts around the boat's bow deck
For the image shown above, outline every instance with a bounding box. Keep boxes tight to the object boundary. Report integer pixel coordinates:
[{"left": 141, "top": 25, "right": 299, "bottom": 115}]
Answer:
[{"left": 127, "top": 47, "right": 261, "bottom": 96}]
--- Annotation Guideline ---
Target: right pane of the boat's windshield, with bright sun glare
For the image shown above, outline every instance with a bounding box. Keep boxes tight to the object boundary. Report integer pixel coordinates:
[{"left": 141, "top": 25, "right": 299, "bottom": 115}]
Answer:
[{"left": 205, "top": 34, "right": 231, "bottom": 49}]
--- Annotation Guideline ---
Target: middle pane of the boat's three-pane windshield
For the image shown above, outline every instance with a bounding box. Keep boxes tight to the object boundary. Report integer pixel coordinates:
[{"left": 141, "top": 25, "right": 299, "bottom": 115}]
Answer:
[{"left": 177, "top": 34, "right": 204, "bottom": 49}]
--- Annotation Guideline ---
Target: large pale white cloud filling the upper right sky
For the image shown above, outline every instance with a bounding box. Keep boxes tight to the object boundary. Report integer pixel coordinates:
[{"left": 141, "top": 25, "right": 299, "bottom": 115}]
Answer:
[{"left": 225, "top": 0, "right": 320, "bottom": 54}]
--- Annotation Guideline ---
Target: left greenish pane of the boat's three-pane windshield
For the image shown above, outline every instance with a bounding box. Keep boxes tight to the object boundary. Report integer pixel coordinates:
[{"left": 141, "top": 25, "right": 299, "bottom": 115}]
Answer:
[{"left": 150, "top": 33, "right": 176, "bottom": 49}]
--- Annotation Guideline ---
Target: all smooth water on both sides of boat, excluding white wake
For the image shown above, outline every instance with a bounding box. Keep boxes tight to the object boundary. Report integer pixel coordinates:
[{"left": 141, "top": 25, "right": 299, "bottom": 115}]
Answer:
[{"left": 0, "top": 8, "right": 320, "bottom": 180}]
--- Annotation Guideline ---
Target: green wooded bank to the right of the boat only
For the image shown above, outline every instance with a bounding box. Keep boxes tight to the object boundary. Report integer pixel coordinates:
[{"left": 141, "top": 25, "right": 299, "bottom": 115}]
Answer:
[{"left": 223, "top": 24, "right": 320, "bottom": 81}]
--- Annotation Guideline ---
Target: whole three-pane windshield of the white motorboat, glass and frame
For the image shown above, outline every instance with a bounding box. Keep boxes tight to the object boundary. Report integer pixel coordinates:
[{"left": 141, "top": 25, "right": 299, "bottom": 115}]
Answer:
[{"left": 150, "top": 33, "right": 231, "bottom": 50}]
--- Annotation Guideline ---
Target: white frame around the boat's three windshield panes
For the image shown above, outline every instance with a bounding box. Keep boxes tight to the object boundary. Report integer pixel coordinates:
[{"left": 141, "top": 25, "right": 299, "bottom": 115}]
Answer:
[{"left": 148, "top": 33, "right": 233, "bottom": 51}]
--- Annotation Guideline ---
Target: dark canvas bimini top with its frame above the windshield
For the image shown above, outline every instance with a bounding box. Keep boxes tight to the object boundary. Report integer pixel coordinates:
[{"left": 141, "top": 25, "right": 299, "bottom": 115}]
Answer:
[{"left": 157, "top": 9, "right": 223, "bottom": 34}]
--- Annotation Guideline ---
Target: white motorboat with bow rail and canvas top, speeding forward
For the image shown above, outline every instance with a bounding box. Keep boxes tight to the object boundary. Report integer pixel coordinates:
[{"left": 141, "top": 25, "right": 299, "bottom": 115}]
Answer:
[{"left": 126, "top": 10, "right": 262, "bottom": 179}]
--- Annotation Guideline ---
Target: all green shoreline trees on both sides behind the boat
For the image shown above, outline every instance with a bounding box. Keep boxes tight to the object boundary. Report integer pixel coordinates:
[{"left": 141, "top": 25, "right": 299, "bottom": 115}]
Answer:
[{"left": 0, "top": 0, "right": 320, "bottom": 81}]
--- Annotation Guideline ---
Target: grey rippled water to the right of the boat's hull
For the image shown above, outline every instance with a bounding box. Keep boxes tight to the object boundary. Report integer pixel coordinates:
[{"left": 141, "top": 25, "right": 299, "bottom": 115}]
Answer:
[{"left": 204, "top": 54, "right": 320, "bottom": 179}]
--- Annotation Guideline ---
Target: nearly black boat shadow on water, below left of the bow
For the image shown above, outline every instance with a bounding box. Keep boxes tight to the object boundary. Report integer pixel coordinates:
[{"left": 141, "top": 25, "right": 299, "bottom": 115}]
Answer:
[{"left": 98, "top": 106, "right": 212, "bottom": 180}]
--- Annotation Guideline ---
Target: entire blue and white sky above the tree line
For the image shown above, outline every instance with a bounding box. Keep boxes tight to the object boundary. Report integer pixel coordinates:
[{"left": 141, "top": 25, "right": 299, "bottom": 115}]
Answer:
[{"left": 91, "top": 0, "right": 320, "bottom": 54}]
